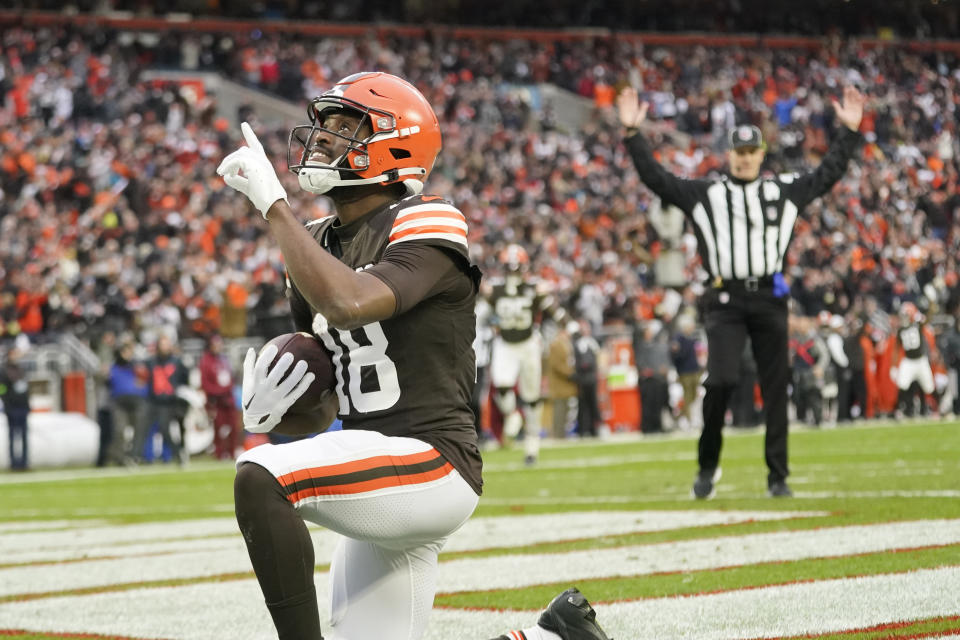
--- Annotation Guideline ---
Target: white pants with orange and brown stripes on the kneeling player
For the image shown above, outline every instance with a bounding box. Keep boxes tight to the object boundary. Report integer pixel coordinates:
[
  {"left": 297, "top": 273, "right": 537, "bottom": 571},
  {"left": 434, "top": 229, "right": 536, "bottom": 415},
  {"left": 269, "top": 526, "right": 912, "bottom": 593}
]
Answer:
[{"left": 237, "top": 430, "right": 479, "bottom": 640}]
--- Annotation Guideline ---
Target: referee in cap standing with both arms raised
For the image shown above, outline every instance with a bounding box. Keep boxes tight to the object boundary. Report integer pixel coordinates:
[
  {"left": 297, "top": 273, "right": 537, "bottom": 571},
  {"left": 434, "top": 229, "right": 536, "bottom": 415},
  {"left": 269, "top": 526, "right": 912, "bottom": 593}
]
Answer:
[{"left": 617, "top": 87, "right": 864, "bottom": 499}]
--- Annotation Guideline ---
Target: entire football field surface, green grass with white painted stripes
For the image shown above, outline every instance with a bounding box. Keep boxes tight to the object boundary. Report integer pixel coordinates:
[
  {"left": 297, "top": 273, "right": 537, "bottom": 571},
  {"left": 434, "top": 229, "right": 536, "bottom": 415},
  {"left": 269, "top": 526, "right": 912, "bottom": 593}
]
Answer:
[{"left": 0, "top": 421, "right": 960, "bottom": 640}]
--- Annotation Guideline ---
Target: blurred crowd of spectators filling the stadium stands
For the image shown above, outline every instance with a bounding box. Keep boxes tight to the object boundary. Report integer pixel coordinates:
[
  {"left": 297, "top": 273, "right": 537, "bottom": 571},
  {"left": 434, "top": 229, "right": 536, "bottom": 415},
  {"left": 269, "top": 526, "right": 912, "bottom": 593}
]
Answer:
[{"left": 0, "top": 21, "right": 960, "bottom": 440}]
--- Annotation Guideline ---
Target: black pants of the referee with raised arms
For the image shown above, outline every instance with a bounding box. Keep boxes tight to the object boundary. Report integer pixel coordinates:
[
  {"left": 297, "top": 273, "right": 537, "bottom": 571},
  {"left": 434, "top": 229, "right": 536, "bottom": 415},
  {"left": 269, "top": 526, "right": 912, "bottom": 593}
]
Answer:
[{"left": 698, "top": 287, "right": 790, "bottom": 485}]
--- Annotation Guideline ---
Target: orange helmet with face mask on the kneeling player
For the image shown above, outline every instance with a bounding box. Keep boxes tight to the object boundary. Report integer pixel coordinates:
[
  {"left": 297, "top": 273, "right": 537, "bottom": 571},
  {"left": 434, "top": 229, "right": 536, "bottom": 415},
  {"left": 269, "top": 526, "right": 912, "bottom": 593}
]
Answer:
[{"left": 287, "top": 71, "right": 442, "bottom": 194}]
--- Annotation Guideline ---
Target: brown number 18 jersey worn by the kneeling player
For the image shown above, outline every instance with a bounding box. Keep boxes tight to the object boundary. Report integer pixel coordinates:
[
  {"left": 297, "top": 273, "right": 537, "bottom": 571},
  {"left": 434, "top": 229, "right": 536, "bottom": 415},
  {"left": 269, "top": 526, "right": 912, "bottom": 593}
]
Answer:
[{"left": 288, "top": 196, "right": 482, "bottom": 494}]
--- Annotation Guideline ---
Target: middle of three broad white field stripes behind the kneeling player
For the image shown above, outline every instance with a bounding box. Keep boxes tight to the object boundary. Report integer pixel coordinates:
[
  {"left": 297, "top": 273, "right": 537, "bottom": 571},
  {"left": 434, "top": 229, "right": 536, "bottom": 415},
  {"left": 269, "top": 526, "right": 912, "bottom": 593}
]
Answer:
[{"left": 0, "top": 520, "right": 960, "bottom": 595}]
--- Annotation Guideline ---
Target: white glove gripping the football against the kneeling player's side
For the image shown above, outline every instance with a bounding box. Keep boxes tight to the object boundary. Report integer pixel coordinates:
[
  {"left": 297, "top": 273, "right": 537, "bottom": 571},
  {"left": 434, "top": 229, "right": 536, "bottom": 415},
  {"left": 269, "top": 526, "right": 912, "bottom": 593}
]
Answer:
[{"left": 243, "top": 344, "right": 315, "bottom": 433}]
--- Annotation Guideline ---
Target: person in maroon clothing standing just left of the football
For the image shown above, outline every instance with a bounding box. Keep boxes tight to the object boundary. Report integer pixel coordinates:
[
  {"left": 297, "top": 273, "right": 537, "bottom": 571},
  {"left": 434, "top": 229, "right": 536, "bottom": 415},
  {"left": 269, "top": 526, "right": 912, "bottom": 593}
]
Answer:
[{"left": 200, "top": 334, "right": 241, "bottom": 460}]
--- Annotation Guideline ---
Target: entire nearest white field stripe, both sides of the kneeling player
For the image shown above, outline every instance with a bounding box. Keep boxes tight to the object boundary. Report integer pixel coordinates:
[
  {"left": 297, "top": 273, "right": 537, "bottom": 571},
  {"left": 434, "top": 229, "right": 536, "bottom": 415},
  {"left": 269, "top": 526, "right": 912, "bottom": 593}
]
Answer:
[{"left": 0, "top": 568, "right": 960, "bottom": 640}]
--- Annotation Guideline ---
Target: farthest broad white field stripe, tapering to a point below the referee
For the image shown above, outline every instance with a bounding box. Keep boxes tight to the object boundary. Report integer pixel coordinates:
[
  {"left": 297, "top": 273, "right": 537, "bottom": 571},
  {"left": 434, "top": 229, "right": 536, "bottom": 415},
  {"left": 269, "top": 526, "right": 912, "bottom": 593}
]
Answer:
[{"left": 0, "top": 511, "right": 818, "bottom": 595}]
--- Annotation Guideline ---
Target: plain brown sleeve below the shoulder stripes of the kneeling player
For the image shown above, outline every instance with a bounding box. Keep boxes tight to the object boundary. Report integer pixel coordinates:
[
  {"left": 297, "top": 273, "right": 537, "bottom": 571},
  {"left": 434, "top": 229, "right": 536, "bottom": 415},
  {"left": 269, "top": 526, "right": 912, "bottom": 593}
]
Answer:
[{"left": 365, "top": 242, "right": 473, "bottom": 316}]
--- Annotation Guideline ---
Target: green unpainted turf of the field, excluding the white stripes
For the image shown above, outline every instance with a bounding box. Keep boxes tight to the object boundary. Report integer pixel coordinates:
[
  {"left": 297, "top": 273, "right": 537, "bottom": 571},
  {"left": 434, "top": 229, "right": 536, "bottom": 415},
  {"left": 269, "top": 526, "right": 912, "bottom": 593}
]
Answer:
[{"left": 0, "top": 421, "right": 960, "bottom": 640}]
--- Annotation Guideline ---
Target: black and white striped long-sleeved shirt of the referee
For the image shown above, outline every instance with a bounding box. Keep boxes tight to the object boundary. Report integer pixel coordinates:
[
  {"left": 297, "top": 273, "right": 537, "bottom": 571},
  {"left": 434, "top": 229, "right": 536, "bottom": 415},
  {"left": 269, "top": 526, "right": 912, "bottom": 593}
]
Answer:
[{"left": 626, "top": 127, "right": 861, "bottom": 280}]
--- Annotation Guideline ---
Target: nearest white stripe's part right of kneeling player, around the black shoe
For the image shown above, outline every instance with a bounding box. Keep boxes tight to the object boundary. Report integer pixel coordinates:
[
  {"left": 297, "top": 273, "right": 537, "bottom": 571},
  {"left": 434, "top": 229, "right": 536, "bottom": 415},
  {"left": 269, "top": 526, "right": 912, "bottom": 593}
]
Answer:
[{"left": 432, "top": 567, "right": 960, "bottom": 640}]
